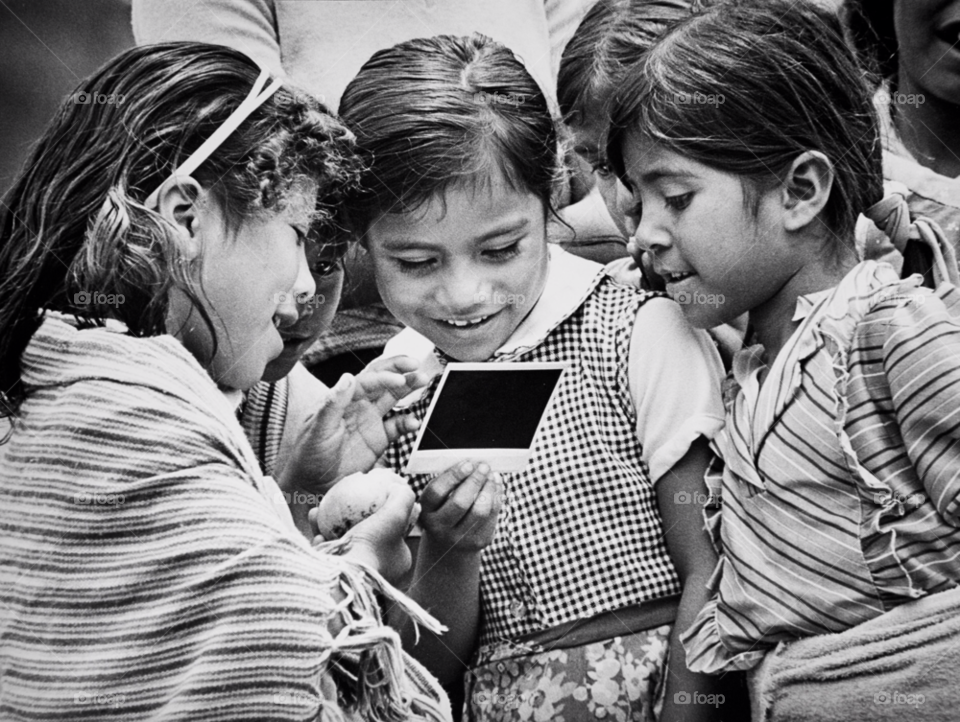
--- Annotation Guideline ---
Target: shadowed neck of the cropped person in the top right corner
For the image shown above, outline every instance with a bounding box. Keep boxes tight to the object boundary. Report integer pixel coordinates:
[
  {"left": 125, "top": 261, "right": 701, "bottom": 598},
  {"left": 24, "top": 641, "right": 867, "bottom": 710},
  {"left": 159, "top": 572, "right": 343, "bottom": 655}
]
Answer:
[{"left": 891, "top": 74, "right": 960, "bottom": 178}]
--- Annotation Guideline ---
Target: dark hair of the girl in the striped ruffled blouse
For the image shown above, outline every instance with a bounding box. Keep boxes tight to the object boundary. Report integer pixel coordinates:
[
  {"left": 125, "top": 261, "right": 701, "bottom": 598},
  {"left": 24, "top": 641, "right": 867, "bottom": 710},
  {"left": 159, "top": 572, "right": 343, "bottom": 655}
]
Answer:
[{"left": 607, "top": 0, "right": 883, "bottom": 243}]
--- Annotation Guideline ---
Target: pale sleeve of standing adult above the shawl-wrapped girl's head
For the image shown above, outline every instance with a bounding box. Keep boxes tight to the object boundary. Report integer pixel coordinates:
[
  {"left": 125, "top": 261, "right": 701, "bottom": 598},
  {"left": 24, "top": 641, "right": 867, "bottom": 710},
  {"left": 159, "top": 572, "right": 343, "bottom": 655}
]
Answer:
[{"left": 130, "top": 0, "right": 283, "bottom": 75}]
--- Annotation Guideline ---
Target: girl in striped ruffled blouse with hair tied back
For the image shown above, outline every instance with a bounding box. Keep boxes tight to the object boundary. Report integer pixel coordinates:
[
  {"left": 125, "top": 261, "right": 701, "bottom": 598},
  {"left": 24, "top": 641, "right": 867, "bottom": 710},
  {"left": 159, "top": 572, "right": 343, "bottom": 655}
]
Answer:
[{"left": 608, "top": 0, "right": 960, "bottom": 720}]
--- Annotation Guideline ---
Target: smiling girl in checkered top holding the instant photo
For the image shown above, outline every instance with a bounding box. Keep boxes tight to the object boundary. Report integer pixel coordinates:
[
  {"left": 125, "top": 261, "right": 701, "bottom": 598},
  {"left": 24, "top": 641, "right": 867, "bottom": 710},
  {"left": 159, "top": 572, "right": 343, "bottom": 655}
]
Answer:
[{"left": 340, "top": 36, "right": 721, "bottom": 720}]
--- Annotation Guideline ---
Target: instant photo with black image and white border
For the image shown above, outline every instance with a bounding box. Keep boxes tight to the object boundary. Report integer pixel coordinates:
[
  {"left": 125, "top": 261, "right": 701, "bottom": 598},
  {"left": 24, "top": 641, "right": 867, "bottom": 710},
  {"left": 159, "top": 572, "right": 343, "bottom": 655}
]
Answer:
[{"left": 404, "top": 363, "right": 567, "bottom": 474}]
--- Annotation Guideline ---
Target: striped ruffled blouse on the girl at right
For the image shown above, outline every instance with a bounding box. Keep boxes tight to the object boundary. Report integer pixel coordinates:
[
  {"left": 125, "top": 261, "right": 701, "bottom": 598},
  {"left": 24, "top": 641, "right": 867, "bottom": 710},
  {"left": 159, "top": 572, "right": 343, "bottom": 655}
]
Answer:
[{"left": 684, "top": 261, "right": 960, "bottom": 672}]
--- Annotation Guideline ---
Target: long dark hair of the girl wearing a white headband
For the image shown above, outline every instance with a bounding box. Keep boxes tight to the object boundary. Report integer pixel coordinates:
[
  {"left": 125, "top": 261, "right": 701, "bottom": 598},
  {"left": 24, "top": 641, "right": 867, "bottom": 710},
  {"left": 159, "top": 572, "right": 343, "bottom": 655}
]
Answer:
[{"left": 0, "top": 43, "right": 358, "bottom": 416}]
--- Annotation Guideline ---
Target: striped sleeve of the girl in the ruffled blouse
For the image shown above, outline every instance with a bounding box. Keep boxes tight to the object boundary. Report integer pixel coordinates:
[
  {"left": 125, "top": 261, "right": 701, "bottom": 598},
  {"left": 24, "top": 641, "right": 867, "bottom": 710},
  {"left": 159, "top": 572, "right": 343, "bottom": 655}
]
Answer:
[{"left": 865, "top": 286, "right": 960, "bottom": 526}]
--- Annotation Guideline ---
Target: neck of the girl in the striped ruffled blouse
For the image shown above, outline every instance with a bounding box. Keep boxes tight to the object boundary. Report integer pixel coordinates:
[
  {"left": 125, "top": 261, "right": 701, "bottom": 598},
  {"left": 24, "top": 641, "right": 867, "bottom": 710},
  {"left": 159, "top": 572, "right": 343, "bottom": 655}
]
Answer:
[{"left": 750, "top": 245, "right": 858, "bottom": 368}]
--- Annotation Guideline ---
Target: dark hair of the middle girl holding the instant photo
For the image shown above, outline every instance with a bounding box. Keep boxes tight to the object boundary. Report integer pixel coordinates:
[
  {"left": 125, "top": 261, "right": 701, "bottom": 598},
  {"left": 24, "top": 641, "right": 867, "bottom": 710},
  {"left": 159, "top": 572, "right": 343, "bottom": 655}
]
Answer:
[{"left": 340, "top": 34, "right": 560, "bottom": 234}]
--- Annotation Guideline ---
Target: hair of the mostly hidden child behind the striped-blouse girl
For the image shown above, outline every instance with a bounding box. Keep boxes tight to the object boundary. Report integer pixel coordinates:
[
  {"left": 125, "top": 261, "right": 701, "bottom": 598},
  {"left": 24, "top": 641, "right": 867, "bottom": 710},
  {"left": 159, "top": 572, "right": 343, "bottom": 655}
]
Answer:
[{"left": 557, "top": 0, "right": 699, "bottom": 122}]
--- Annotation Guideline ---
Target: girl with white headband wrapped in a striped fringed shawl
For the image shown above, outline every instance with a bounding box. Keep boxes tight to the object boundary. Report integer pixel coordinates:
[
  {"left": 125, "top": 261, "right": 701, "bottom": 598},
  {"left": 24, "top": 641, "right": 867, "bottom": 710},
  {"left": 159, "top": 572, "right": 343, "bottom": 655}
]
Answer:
[{"left": 0, "top": 43, "right": 449, "bottom": 720}]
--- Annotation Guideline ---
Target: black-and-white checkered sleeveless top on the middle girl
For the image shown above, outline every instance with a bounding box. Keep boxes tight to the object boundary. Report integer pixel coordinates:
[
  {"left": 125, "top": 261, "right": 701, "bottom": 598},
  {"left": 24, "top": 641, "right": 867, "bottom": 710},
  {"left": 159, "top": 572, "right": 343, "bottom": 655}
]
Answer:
[{"left": 386, "top": 274, "right": 680, "bottom": 646}]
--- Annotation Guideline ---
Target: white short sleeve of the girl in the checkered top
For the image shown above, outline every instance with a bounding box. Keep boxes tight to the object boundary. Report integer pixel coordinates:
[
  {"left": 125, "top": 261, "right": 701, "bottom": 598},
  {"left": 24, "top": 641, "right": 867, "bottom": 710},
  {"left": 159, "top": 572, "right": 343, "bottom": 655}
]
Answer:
[{"left": 627, "top": 298, "right": 724, "bottom": 483}]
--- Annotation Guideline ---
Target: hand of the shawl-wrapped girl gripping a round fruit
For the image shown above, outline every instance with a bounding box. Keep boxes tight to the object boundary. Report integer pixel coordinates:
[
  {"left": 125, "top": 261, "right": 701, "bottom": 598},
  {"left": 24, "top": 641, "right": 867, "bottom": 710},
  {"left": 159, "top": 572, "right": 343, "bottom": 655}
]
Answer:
[{"left": 309, "top": 483, "right": 417, "bottom": 583}]
